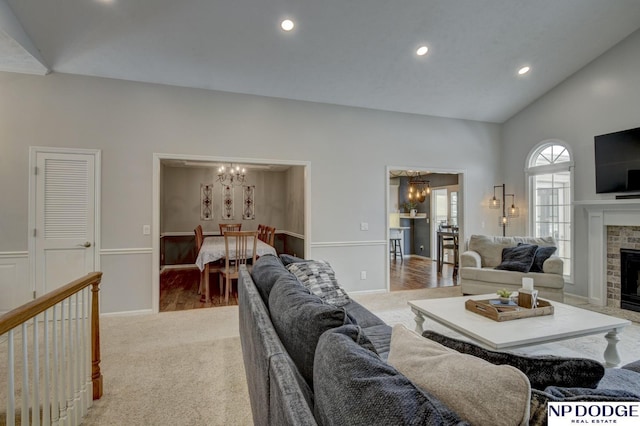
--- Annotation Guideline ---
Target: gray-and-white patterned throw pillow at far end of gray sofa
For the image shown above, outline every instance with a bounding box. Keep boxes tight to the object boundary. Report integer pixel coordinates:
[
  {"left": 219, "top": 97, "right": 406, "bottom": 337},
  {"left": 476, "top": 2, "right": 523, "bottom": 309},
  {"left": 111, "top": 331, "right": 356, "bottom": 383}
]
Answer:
[{"left": 286, "top": 260, "right": 350, "bottom": 306}]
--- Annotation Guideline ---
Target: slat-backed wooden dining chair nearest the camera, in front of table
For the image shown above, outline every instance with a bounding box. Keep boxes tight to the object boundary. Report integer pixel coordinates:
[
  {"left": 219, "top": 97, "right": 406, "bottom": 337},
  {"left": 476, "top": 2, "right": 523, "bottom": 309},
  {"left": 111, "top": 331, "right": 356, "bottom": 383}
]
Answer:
[{"left": 220, "top": 231, "right": 258, "bottom": 305}]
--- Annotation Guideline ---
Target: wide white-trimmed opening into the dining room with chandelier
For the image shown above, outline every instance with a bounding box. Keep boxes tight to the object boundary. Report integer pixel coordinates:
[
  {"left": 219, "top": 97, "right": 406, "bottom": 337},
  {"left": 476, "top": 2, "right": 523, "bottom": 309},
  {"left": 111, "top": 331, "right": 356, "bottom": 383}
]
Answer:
[{"left": 151, "top": 154, "right": 310, "bottom": 312}]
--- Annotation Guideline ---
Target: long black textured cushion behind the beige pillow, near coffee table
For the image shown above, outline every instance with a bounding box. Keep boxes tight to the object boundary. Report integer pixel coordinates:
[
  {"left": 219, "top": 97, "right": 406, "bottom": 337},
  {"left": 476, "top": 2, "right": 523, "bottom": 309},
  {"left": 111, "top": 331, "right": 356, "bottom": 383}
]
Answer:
[{"left": 422, "top": 330, "right": 605, "bottom": 389}]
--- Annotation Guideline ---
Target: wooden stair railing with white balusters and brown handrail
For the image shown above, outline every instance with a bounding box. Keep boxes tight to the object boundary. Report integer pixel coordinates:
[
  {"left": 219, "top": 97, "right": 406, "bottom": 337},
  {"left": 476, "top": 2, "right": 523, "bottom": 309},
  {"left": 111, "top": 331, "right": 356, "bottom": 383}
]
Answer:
[{"left": 0, "top": 272, "right": 102, "bottom": 426}]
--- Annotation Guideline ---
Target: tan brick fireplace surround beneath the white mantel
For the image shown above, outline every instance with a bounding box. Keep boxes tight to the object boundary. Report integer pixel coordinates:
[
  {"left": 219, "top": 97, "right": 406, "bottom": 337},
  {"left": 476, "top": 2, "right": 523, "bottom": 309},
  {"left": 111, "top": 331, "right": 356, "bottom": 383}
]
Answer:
[{"left": 607, "top": 226, "right": 640, "bottom": 310}]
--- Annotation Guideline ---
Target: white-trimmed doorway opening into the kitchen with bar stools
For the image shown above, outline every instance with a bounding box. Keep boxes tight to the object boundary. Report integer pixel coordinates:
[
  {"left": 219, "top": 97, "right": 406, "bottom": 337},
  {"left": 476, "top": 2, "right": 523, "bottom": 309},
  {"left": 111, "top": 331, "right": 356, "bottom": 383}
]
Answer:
[{"left": 386, "top": 166, "right": 465, "bottom": 291}]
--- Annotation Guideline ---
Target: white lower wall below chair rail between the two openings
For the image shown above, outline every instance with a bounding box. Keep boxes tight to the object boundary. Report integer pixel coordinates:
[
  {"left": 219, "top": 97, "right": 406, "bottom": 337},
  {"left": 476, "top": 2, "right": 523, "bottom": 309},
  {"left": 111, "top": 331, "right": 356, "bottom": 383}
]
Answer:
[{"left": 306, "top": 241, "right": 389, "bottom": 292}]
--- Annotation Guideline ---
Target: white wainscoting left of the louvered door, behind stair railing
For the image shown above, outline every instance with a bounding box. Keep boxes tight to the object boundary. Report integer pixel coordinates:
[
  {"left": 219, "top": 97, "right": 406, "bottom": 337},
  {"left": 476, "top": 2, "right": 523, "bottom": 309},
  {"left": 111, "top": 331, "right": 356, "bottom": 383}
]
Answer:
[{"left": 0, "top": 252, "right": 33, "bottom": 314}]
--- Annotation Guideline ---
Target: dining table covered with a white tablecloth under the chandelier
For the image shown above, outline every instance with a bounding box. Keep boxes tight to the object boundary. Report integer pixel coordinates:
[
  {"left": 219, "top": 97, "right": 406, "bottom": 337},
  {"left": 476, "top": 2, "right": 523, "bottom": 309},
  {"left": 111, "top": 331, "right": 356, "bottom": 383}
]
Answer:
[{"left": 196, "top": 235, "right": 277, "bottom": 301}]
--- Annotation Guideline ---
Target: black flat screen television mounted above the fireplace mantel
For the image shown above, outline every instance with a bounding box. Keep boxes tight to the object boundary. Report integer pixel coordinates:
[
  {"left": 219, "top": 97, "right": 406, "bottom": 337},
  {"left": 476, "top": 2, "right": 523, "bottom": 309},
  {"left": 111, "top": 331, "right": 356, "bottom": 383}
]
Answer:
[{"left": 594, "top": 127, "right": 640, "bottom": 194}]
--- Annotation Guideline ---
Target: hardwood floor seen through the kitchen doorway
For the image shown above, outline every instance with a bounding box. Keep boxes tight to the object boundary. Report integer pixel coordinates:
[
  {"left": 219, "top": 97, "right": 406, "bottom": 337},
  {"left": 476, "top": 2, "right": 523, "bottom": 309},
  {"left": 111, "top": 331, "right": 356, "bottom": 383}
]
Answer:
[{"left": 389, "top": 256, "right": 458, "bottom": 291}]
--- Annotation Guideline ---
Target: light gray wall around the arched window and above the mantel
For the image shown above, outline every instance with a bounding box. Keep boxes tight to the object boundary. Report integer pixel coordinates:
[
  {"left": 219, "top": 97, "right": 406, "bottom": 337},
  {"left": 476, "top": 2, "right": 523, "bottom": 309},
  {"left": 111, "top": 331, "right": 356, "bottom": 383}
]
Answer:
[{"left": 502, "top": 27, "right": 640, "bottom": 296}]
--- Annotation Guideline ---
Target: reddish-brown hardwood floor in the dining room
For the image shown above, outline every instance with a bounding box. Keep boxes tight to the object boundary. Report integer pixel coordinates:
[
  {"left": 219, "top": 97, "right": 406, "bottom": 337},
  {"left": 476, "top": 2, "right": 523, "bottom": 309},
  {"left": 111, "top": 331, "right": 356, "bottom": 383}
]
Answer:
[{"left": 160, "top": 268, "right": 238, "bottom": 312}]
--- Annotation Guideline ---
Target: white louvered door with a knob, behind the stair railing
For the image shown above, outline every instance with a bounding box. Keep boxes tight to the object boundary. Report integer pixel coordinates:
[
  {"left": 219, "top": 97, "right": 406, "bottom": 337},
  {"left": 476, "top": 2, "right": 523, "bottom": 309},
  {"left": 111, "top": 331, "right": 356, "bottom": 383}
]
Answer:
[{"left": 35, "top": 152, "right": 96, "bottom": 296}]
